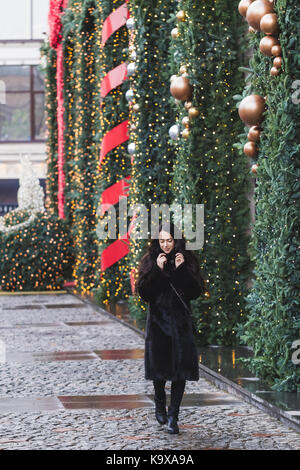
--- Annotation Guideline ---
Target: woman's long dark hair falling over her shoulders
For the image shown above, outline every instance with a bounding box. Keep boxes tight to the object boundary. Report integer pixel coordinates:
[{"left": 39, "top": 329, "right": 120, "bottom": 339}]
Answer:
[{"left": 135, "top": 222, "right": 200, "bottom": 294}]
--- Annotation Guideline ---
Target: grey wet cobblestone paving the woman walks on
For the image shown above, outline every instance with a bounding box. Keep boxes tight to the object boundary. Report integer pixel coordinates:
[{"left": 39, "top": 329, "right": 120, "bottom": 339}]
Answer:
[{"left": 0, "top": 294, "right": 300, "bottom": 450}]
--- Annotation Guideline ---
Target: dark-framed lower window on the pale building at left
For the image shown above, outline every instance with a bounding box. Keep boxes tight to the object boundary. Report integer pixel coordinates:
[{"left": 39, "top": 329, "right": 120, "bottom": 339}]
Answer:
[{"left": 0, "top": 65, "right": 46, "bottom": 143}]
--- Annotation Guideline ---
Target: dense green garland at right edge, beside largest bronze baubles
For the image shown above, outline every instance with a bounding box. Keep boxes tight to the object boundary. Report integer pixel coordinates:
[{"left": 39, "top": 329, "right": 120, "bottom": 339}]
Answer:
[{"left": 240, "top": 0, "right": 300, "bottom": 391}]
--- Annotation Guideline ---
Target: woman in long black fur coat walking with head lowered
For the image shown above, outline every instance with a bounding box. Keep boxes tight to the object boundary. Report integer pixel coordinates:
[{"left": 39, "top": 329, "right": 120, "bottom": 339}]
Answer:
[{"left": 136, "top": 222, "right": 204, "bottom": 434}]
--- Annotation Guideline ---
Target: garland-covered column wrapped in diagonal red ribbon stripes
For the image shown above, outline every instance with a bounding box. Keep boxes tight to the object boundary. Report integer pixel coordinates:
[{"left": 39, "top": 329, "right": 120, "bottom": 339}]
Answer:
[{"left": 95, "top": 0, "right": 131, "bottom": 307}]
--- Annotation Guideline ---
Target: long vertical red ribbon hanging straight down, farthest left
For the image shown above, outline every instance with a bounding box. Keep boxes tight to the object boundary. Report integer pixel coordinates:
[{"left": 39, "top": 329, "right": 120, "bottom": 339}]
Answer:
[{"left": 48, "top": 0, "right": 68, "bottom": 219}]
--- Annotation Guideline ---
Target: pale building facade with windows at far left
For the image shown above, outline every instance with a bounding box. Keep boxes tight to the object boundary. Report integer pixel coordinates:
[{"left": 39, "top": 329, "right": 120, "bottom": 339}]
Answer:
[{"left": 0, "top": 0, "right": 49, "bottom": 215}]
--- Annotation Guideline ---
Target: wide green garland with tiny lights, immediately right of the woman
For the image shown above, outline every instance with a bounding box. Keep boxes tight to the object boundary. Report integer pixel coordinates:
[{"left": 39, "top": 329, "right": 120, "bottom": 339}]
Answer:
[{"left": 171, "top": 0, "right": 252, "bottom": 345}]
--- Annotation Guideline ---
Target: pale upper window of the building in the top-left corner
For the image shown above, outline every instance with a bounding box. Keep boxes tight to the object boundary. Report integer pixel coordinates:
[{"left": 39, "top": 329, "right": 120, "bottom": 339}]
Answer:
[{"left": 0, "top": 0, "right": 49, "bottom": 41}]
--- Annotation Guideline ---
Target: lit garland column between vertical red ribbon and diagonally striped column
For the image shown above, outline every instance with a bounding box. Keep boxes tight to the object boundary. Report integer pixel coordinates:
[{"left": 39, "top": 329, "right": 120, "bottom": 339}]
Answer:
[{"left": 64, "top": 0, "right": 101, "bottom": 294}]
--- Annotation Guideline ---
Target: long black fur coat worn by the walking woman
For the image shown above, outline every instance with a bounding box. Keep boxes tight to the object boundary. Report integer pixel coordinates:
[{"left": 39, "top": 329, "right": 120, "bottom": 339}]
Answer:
[{"left": 137, "top": 256, "right": 204, "bottom": 381}]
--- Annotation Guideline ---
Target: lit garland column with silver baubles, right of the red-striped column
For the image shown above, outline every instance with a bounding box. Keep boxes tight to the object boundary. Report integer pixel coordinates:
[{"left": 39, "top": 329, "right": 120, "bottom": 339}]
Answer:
[{"left": 127, "top": 0, "right": 175, "bottom": 324}]
